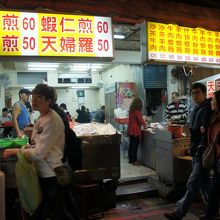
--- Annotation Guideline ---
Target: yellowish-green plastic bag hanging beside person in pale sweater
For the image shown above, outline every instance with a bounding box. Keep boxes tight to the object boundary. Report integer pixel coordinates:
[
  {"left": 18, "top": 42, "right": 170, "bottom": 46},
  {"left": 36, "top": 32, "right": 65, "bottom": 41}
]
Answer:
[{"left": 15, "top": 152, "right": 42, "bottom": 215}]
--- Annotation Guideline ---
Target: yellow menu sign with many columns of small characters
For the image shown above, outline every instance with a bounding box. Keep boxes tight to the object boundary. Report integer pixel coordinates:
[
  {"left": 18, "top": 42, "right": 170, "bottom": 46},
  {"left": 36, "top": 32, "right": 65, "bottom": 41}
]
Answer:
[{"left": 147, "top": 22, "right": 220, "bottom": 64}]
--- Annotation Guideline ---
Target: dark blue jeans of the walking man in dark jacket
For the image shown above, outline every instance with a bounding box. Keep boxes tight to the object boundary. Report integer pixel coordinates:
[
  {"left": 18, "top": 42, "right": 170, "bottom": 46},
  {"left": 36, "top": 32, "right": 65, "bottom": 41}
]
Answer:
[{"left": 176, "top": 153, "right": 209, "bottom": 216}]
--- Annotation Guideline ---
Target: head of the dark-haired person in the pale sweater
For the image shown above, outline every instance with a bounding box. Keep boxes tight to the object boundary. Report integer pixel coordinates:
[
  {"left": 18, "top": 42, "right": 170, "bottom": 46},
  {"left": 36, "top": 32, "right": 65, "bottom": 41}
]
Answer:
[{"left": 32, "top": 84, "right": 57, "bottom": 113}]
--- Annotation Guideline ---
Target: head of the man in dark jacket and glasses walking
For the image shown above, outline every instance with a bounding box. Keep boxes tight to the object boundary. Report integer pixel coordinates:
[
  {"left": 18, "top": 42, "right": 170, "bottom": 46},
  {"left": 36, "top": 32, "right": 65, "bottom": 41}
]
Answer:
[{"left": 191, "top": 83, "right": 206, "bottom": 104}]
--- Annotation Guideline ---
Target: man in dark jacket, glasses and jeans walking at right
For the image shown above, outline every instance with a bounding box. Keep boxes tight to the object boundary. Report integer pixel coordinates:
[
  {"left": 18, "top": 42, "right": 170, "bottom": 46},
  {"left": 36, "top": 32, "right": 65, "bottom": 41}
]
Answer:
[{"left": 164, "top": 83, "right": 212, "bottom": 220}]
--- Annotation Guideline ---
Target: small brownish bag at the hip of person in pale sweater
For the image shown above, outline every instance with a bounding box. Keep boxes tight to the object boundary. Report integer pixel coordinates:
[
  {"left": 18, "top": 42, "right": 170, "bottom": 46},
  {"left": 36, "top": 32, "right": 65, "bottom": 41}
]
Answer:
[{"left": 54, "top": 164, "right": 73, "bottom": 186}]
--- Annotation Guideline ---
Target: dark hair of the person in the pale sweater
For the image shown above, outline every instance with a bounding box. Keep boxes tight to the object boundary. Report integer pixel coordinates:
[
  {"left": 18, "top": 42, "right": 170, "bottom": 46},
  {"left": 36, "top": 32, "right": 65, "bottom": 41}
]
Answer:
[{"left": 32, "top": 84, "right": 57, "bottom": 107}]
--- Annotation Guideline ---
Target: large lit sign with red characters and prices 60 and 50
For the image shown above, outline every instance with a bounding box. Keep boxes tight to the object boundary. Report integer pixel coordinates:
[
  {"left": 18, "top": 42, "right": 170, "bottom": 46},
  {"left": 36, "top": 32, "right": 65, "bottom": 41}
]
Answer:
[{"left": 0, "top": 11, "right": 113, "bottom": 57}]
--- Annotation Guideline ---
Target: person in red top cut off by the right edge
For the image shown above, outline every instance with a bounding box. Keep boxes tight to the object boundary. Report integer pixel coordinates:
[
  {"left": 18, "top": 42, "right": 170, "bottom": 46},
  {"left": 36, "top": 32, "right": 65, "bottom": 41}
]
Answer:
[{"left": 200, "top": 91, "right": 220, "bottom": 220}]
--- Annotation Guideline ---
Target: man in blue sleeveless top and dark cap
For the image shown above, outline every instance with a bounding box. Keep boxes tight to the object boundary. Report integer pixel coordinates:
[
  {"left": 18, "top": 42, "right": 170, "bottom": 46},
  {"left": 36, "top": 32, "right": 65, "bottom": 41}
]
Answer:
[{"left": 12, "top": 89, "right": 31, "bottom": 137}]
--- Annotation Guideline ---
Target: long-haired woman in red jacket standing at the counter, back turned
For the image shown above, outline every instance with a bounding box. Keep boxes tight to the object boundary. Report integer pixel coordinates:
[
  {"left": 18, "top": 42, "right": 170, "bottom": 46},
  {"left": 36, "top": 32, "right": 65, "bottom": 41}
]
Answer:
[{"left": 128, "top": 97, "right": 145, "bottom": 165}]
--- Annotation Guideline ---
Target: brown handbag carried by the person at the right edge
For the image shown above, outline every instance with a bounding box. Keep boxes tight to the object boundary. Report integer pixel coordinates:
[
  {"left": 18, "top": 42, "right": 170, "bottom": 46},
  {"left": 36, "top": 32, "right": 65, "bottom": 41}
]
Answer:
[{"left": 202, "top": 138, "right": 217, "bottom": 170}]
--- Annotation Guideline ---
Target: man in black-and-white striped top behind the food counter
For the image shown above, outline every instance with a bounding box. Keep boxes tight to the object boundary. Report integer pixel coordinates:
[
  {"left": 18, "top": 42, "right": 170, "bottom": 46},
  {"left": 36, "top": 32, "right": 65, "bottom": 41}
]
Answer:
[{"left": 165, "top": 92, "right": 188, "bottom": 124}]
